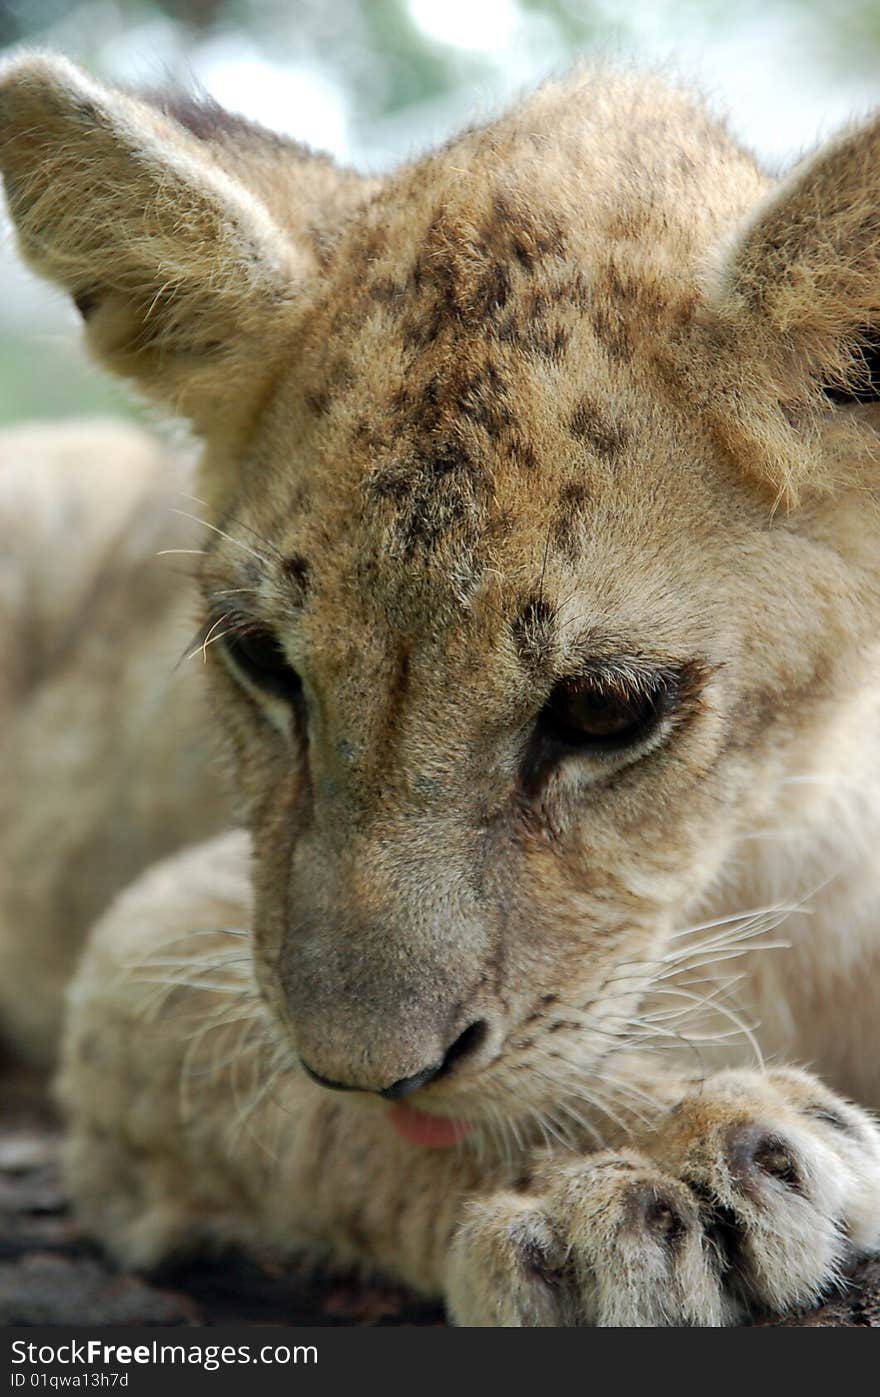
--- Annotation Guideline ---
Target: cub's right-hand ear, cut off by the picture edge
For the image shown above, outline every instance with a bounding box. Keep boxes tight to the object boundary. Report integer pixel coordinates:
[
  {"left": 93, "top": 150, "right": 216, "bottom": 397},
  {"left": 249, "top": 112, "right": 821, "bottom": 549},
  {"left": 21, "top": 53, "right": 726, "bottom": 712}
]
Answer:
[{"left": 710, "top": 116, "right": 880, "bottom": 502}]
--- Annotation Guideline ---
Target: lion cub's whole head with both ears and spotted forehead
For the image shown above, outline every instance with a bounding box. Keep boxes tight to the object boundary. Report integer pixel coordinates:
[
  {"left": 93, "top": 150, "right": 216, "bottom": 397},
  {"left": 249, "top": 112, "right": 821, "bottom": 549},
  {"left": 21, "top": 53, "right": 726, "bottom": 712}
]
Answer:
[{"left": 0, "top": 57, "right": 880, "bottom": 1134}]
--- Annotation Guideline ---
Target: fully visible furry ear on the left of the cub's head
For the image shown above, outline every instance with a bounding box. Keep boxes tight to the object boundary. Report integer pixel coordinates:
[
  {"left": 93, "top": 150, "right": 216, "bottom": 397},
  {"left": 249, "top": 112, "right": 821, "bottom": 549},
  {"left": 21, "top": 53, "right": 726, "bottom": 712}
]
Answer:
[{"left": 0, "top": 57, "right": 313, "bottom": 430}]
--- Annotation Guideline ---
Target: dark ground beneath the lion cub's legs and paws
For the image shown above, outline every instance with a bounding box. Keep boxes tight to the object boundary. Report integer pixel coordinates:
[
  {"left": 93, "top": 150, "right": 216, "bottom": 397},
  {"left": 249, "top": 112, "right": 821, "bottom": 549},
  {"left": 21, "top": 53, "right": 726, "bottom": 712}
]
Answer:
[{"left": 0, "top": 1067, "right": 880, "bottom": 1329}]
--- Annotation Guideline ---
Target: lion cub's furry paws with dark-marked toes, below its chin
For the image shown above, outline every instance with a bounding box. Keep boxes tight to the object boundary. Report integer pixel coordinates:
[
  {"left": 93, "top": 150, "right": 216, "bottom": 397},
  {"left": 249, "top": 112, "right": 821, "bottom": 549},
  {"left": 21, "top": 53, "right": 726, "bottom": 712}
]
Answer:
[{"left": 447, "top": 1070, "right": 880, "bottom": 1326}]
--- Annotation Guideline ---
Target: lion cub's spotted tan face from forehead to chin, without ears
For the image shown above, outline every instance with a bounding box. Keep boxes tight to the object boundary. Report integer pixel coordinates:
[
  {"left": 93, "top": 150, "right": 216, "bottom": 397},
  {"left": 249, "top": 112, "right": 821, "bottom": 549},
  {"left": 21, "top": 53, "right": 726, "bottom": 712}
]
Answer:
[{"left": 204, "top": 171, "right": 880, "bottom": 1115}]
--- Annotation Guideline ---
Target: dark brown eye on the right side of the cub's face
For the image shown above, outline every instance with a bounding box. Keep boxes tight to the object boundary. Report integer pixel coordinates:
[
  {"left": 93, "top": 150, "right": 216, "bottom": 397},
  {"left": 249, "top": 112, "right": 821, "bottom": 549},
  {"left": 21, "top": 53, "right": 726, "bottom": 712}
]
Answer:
[{"left": 538, "top": 678, "right": 666, "bottom": 752}]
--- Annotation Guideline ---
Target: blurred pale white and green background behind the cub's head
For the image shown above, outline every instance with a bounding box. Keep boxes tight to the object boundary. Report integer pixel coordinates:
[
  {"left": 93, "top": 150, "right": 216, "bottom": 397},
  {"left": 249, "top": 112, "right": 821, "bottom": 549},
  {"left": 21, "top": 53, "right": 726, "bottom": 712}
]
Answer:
[{"left": 0, "top": 0, "right": 880, "bottom": 422}]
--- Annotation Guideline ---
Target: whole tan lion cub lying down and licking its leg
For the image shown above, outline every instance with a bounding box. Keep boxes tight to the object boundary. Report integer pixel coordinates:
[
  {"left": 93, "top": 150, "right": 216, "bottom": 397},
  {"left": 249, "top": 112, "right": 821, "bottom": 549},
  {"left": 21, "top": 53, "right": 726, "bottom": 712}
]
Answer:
[{"left": 0, "top": 56, "right": 880, "bottom": 1324}]
